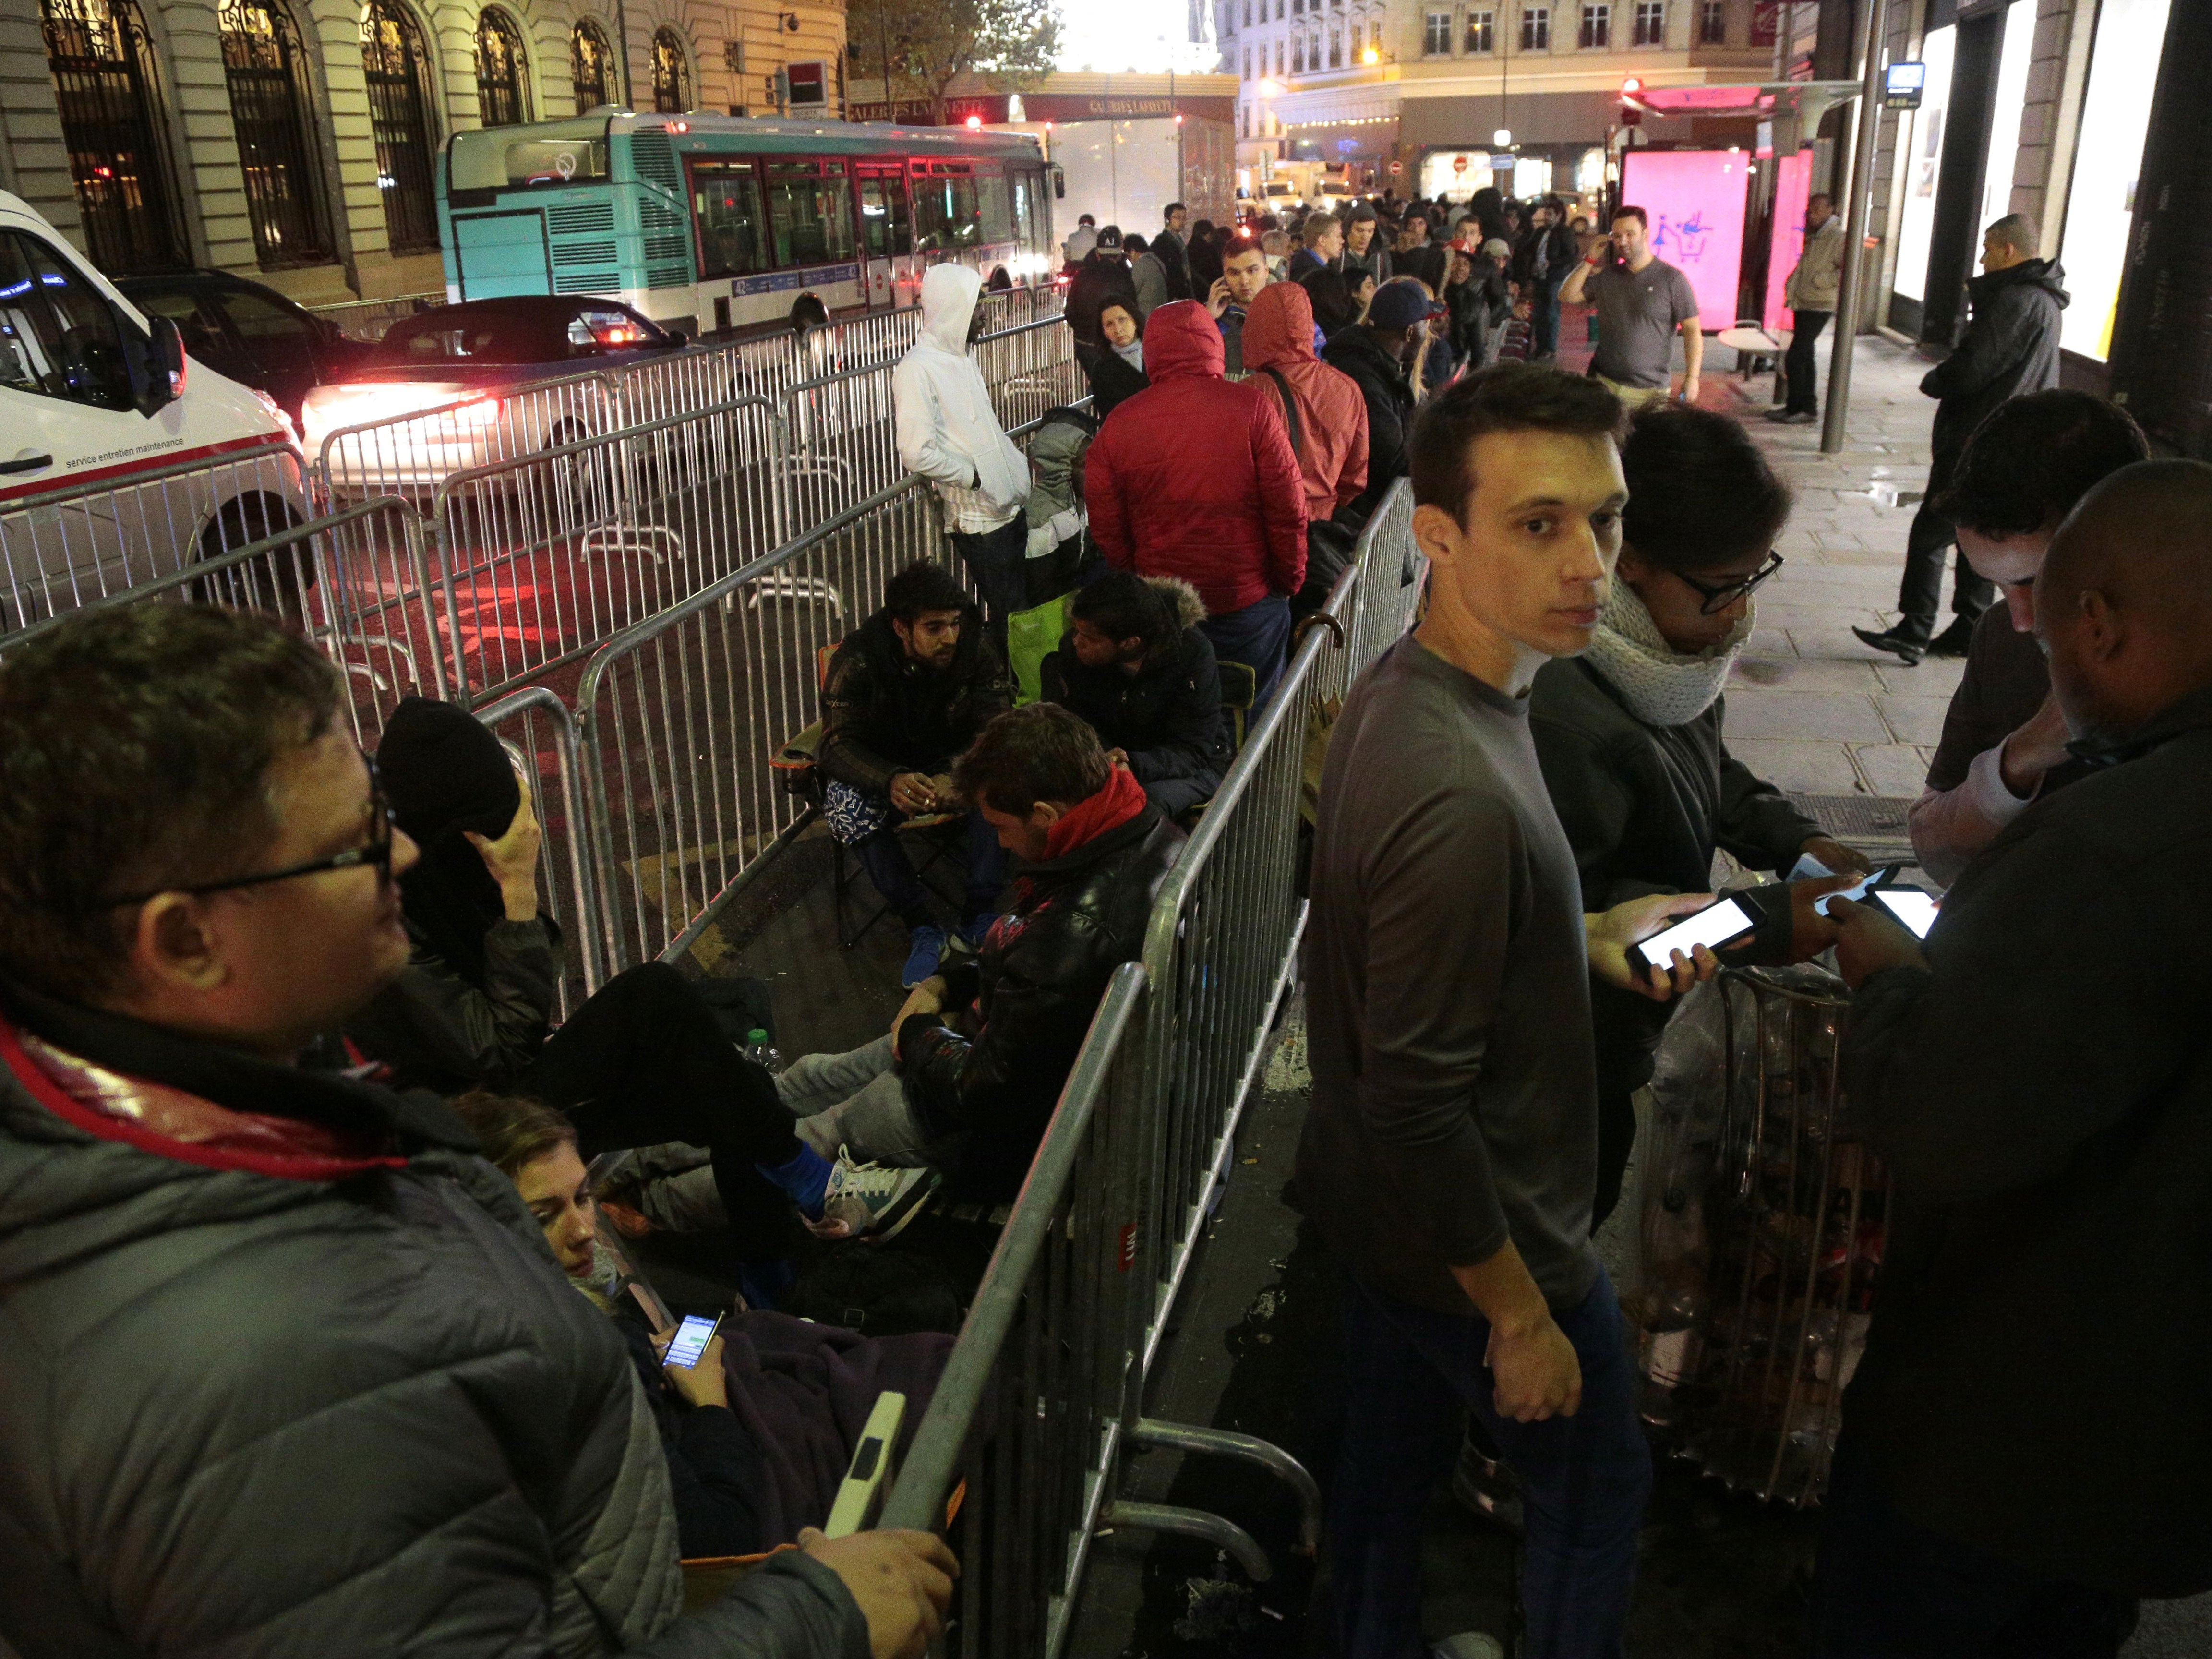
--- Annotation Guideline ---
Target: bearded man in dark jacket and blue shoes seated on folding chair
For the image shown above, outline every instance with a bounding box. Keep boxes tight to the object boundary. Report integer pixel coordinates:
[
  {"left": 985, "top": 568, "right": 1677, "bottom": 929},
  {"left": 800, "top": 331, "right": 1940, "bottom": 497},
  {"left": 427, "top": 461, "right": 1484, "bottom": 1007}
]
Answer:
[{"left": 821, "top": 562, "right": 1013, "bottom": 986}]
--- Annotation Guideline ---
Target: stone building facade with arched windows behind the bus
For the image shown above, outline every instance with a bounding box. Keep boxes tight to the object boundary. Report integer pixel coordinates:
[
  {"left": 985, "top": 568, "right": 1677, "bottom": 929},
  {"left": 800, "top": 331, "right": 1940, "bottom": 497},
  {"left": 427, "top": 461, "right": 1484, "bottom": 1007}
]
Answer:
[{"left": 0, "top": 0, "right": 845, "bottom": 303}]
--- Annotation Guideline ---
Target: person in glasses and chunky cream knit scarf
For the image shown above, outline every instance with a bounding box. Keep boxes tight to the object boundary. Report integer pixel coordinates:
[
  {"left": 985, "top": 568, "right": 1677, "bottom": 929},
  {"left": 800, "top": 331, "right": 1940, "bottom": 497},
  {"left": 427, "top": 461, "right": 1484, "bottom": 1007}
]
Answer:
[{"left": 1528, "top": 405, "right": 1871, "bottom": 1230}]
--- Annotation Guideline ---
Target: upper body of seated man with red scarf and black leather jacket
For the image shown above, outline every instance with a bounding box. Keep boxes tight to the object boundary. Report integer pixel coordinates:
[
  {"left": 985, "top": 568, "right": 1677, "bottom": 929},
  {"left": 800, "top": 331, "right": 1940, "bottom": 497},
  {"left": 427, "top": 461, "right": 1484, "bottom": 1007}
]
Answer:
[{"left": 891, "top": 703, "right": 1183, "bottom": 1197}]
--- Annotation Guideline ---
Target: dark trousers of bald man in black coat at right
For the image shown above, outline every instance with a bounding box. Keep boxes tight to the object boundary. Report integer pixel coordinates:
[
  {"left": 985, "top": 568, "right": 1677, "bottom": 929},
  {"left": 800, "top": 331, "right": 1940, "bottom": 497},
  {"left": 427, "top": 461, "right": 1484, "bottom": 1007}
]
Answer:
[{"left": 1812, "top": 1424, "right": 2135, "bottom": 1659}]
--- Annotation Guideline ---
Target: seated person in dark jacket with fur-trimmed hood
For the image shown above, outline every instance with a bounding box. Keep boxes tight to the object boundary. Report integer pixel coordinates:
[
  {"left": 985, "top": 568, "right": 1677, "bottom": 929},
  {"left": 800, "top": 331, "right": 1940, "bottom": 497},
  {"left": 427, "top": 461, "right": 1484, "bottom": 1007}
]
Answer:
[{"left": 1042, "top": 571, "right": 1234, "bottom": 818}]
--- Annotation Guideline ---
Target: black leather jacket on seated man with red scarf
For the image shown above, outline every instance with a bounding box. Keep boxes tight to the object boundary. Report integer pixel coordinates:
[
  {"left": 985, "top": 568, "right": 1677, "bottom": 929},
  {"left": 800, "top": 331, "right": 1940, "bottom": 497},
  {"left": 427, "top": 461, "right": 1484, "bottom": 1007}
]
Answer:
[{"left": 898, "top": 807, "right": 1183, "bottom": 1194}]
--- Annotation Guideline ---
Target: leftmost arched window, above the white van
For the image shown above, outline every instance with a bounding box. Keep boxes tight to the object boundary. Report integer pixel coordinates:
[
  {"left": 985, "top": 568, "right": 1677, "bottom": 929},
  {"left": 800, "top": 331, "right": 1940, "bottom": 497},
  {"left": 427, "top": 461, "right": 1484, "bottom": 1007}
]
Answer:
[{"left": 44, "top": 0, "right": 190, "bottom": 276}]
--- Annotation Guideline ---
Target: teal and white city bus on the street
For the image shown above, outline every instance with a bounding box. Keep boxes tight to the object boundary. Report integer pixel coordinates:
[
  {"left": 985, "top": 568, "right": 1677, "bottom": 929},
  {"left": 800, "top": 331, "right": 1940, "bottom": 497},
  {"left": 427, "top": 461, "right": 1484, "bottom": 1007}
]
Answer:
[{"left": 438, "top": 113, "right": 1058, "bottom": 334}]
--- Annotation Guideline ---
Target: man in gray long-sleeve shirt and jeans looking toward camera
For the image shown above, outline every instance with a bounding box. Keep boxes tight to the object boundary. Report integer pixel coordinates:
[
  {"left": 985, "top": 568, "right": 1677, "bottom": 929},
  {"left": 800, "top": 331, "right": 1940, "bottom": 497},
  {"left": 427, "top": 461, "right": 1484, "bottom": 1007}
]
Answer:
[{"left": 1296, "top": 363, "right": 1714, "bottom": 1659}]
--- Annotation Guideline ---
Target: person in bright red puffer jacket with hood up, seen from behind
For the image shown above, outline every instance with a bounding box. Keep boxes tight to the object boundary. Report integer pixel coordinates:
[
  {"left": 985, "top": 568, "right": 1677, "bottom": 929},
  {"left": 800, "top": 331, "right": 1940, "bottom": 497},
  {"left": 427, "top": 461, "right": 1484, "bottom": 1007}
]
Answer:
[{"left": 1084, "top": 301, "right": 1305, "bottom": 703}]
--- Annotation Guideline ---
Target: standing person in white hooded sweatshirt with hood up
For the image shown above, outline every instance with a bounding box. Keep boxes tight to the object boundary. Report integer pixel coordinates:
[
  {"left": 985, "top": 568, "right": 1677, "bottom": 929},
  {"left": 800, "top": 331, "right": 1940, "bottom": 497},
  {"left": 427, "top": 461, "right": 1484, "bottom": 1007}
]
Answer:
[{"left": 891, "top": 263, "right": 1029, "bottom": 655}]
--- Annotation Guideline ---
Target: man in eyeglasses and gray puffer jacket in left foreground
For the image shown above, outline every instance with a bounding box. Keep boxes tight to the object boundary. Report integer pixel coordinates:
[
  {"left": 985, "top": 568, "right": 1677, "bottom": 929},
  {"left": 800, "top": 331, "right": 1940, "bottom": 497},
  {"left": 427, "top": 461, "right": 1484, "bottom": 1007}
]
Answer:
[{"left": 0, "top": 604, "right": 953, "bottom": 1659}]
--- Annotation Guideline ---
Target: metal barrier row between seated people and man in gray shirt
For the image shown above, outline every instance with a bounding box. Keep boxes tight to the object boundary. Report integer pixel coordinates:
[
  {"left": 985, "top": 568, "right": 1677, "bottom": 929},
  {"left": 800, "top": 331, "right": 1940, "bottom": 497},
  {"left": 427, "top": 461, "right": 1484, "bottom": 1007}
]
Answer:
[{"left": 883, "top": 482, "right": 1422, "bottom": 1659}]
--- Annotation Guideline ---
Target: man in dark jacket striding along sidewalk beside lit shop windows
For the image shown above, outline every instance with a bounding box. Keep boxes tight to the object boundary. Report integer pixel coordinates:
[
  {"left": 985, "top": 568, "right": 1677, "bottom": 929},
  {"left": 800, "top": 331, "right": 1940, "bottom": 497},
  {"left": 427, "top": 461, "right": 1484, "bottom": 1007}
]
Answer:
[{"left": 1851, "top": 212, "right": 2066, "bottom": 663}]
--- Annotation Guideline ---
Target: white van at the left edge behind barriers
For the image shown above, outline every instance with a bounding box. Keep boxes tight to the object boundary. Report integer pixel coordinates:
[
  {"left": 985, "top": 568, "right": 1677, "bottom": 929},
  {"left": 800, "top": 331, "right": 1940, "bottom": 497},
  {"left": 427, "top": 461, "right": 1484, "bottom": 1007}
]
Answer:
[{"left": 0, "top": 190, "right": 314, "bottom": 639}]
